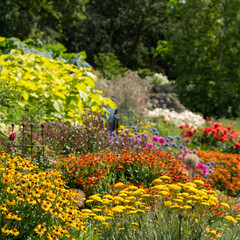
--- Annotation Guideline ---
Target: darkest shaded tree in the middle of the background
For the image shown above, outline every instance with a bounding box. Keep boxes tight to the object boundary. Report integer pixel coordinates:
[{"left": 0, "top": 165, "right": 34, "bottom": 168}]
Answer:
[{"left": 65, "top": 0, "right": 168, "bottom": 68}]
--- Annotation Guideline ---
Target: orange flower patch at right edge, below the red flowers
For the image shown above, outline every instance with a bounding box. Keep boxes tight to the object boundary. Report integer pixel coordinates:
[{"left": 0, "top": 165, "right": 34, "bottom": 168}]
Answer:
[{"left": 198, "top": 150, "right": 240, "bottom": 196}]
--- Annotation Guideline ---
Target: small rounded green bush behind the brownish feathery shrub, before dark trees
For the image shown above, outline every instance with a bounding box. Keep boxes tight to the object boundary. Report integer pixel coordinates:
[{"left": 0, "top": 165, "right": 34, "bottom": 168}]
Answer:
[{"left": 94, "top": 53, "right": 127, "bottom": 80}]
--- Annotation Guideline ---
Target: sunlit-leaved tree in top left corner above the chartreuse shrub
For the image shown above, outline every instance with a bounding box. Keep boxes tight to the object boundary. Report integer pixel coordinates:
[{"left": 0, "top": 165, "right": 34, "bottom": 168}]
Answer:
[{"left": 0, "top": 0, "right": 88, "bottom": 42}]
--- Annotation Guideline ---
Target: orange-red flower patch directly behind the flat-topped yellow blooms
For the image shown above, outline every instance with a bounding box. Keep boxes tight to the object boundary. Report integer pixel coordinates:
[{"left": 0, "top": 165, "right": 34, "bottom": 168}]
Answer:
[{"left": 57, "top": 150, "right": 188, "bottom": 193}]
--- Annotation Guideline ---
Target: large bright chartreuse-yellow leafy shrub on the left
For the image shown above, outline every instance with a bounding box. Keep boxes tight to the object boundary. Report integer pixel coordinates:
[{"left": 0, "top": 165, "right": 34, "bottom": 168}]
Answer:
[{"left": 0, "top": 50, "right": 115, "bottom": 122}]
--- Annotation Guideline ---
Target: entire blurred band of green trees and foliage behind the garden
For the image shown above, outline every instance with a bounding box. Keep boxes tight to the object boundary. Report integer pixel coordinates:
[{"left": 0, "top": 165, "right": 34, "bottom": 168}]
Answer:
[{"left": 0, "top": 0, "right": 240, "bottom": 118}]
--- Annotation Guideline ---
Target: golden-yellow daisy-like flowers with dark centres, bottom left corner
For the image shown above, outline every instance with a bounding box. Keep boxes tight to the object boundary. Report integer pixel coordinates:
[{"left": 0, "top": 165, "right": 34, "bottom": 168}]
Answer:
[{"left": 0, "top": 152, "right": 86, "bottom": 239}]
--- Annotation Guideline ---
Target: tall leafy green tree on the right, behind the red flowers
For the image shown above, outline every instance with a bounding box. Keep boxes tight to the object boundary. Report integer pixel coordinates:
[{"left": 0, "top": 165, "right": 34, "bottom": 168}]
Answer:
[{"left": 161, "top": 0, "right": 240, "bottom": 117}]
